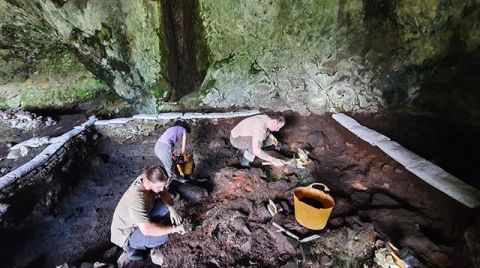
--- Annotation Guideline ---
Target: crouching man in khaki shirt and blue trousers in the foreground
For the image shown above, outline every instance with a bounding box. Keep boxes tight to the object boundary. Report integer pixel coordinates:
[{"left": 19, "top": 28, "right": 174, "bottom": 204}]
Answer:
[{"left": 111, "top": 166, "right": 185, "bottom": 265}]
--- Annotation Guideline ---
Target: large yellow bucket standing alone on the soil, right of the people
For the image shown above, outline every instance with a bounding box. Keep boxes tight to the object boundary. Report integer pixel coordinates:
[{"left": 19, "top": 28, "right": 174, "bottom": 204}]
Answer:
[{"left": 293, "top": 183, "right": 335, "bottom": 230}]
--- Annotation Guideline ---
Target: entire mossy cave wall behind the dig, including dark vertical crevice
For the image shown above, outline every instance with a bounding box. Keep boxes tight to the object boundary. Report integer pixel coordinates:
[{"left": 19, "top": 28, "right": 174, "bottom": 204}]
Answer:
[{"left": 0, "top": 0, "right": 480, "bottom": 122}]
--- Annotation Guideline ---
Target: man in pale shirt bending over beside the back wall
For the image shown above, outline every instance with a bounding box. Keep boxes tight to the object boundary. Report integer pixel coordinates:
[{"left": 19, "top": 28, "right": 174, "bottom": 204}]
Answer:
[{"left": 230, "top": 112, "right": 285, "bottom": 167}]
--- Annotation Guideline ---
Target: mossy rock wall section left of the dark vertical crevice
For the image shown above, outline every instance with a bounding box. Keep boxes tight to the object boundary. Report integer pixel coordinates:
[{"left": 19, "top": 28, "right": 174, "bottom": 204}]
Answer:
[{"left": 0, "top": 0, "right": 169, "bottom": 111}]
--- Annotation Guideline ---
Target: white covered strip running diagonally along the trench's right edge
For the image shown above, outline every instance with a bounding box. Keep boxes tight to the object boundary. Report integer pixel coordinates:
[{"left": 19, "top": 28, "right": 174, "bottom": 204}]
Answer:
[{"left": 332, "top": 113, "right": 480, "bottom": 208}]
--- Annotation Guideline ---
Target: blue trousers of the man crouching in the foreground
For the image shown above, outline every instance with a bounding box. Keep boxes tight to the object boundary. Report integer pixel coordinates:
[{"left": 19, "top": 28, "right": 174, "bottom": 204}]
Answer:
[{"left": 127, "top": 199, "right": 168, "bottom": 250}]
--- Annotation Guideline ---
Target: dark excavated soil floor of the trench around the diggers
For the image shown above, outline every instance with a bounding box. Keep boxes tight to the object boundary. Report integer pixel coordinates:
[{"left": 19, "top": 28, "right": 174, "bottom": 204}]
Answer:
[{"left": 2, "top": 113, "right": 478, "bottom": 267}]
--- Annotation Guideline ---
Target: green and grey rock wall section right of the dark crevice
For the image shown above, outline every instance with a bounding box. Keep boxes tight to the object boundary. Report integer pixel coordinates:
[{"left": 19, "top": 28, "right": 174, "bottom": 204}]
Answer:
[{"left": 189, "top": 0, "right": 480, "bottom": 119}]
